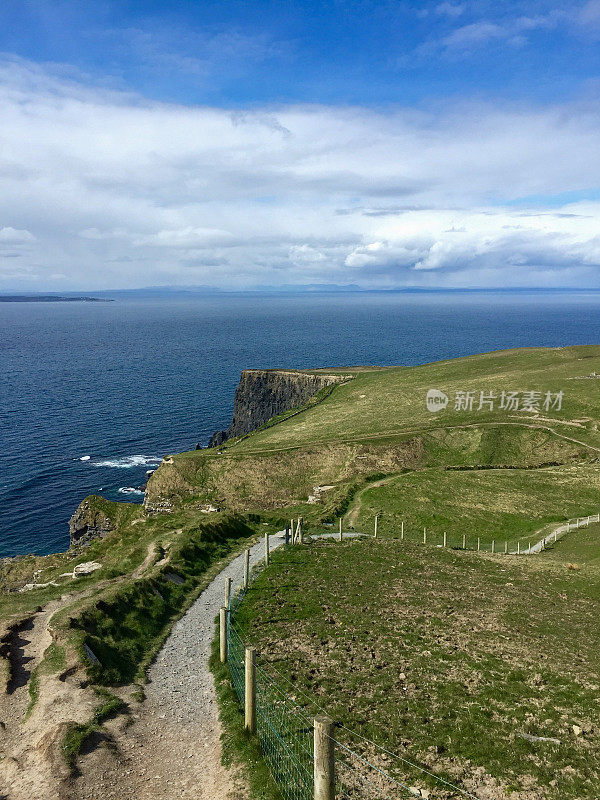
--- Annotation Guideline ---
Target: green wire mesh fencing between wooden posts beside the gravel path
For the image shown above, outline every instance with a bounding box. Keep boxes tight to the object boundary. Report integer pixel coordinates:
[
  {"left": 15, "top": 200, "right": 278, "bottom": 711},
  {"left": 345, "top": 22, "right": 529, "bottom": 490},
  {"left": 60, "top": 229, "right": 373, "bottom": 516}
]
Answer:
[{"left": 226, "top": 564, "right": 477, "bottom": 800}]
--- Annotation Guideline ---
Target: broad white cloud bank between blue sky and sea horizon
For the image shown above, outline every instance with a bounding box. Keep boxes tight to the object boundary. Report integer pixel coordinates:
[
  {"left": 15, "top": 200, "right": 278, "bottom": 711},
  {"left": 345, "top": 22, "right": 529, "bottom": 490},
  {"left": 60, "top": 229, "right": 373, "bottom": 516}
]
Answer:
[{"left": 0, "top": 55, "right": 600, "bottom": 290}]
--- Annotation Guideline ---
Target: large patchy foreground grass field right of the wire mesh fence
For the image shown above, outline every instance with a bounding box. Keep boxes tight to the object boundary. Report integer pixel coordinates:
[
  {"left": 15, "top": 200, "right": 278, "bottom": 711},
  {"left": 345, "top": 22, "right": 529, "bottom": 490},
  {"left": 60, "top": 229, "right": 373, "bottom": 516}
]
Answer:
[{"left": 230, "top": 526, "right": 600, "bottom": 800}]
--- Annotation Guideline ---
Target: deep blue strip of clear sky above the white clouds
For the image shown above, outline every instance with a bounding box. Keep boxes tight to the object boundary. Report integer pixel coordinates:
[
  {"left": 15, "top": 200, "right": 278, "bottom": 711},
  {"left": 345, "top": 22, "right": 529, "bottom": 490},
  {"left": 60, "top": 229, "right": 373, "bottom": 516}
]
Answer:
[{"left": 0, "top": 0, "right": 600, "bottom": 107}]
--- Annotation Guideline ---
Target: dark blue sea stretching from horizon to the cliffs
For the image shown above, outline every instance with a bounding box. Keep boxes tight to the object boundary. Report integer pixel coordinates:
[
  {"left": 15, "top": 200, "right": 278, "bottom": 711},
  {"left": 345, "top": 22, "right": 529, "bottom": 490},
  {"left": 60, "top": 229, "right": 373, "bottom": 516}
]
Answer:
[{"left": 0, "top": 292, "right": 600, "bottom": 556}]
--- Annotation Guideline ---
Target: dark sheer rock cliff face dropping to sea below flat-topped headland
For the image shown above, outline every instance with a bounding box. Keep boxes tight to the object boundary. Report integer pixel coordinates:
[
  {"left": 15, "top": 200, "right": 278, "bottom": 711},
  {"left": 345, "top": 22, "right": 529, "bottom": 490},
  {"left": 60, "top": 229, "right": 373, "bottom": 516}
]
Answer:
[{"left": 210, "top": 369, "right": 349, "bottom": 447}]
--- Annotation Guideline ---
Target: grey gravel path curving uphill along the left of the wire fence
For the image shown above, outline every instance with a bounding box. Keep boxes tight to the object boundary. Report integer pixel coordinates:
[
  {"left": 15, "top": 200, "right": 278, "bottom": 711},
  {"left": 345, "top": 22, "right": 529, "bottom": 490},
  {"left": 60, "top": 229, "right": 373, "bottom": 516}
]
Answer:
[{"left": 68, "top": 533, "right": 361, "bottom": 800}]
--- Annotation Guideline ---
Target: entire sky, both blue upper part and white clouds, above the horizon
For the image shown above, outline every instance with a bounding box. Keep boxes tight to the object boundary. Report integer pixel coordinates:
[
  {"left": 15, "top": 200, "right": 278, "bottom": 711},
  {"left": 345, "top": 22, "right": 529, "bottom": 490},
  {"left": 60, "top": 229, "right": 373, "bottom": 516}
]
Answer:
[{"left": 0, "top": 0, "right": 600, "bottom": 292}]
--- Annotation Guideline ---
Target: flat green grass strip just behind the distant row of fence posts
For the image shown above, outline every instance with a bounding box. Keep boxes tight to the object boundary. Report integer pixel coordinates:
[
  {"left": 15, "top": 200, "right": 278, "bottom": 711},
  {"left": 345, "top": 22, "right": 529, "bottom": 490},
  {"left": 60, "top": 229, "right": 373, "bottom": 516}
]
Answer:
[{"left": 349, "top": 464, "right": 600, "bottom": 549}]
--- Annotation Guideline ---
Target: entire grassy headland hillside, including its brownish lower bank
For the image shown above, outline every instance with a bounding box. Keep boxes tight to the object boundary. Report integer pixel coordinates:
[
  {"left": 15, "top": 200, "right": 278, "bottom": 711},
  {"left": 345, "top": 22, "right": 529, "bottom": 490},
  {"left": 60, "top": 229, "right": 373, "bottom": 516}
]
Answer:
[{"left": 149, "top": 346, "right": 600, "bottom": 521}]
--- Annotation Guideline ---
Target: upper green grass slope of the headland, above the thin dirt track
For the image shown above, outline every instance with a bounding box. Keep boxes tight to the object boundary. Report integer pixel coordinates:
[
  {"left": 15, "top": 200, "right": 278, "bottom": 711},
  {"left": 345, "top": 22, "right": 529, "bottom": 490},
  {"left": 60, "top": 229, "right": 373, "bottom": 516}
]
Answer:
[{"left": 227, "top": 346, "right": 600, "bottom": 452}]
